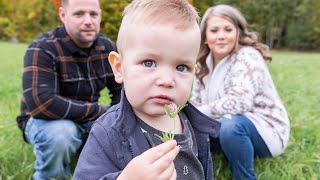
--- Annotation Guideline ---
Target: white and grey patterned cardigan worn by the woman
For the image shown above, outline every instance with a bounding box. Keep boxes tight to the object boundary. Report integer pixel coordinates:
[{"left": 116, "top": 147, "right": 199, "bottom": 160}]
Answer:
[{"left": 191, "top": 47, "right": 290, "bottom": 156}]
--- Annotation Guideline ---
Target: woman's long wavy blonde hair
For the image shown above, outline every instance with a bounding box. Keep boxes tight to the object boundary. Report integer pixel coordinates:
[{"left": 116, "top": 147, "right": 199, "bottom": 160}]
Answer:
[{"left": 196, "top": 4, "right": 272, "bottom": 86}]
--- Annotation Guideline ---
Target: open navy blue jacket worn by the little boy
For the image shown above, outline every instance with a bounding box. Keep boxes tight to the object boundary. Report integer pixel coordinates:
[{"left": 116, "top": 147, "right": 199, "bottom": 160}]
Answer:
[{"left": 73, "top": 91, "right": 220, "bottom": 180}]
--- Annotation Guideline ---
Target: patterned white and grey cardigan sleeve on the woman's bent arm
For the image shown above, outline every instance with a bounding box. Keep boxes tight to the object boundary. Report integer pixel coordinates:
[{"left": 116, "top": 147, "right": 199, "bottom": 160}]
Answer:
[{"left": 198, "top": 48, "right": 268, "bottom": 118}]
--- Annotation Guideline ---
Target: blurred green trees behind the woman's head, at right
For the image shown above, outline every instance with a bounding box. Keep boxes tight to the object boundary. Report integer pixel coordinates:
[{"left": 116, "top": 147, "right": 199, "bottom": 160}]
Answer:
[{"left": 193, "top": 0, "right": 320, "bottom": 50}]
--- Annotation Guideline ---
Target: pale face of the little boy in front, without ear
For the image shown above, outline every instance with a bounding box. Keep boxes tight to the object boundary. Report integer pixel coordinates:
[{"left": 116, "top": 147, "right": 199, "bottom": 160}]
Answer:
[{"left": 121, "top": 24, "right": 200, "bottom": 119}]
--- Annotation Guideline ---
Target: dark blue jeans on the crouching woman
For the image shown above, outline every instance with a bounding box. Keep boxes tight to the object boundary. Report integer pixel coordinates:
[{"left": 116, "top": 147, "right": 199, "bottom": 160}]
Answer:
[{"left": 212, "top": 115, "right": 271, "bottom": 180}]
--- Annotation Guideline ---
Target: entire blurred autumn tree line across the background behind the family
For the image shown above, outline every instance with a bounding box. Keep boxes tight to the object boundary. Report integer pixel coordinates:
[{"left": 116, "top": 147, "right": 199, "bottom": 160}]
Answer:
[{"left": 0, "top": 0, "right": 320, "bottom": 50}]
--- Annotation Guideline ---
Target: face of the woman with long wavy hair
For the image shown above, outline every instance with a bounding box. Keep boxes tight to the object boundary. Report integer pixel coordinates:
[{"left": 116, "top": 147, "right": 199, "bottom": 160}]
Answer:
[{"left": 205, "top": 16, "right": 238, "bottom": 61}]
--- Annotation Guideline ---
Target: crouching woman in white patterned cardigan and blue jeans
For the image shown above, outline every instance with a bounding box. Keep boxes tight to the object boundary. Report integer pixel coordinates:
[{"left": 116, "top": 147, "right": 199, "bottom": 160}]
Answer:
[{"left": 191, "top": 5, "right": 290, "bottom": 179}]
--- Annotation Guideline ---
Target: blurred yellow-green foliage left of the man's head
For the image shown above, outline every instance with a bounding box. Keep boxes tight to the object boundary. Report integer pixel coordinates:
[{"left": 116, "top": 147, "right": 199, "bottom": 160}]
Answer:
[{"left": 0, "top": 0, "right": 60, "bottom": 42}]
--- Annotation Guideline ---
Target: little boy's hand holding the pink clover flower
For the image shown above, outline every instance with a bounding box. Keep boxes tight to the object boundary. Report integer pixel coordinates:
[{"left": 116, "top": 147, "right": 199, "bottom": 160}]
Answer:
[{"left": 117, "top": 140, "right": 180, "bottom": 180}]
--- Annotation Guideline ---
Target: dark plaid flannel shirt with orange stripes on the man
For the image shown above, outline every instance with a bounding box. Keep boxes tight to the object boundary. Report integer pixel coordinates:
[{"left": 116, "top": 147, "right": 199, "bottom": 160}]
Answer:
[{"left": 17, "top": 26, "right": 121, "bottom": 135}]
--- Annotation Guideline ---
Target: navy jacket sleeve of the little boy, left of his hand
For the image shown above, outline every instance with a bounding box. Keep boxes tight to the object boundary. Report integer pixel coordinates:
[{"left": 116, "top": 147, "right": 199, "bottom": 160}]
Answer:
[{"left": 73, "top": 123, "right": 122, "bottom": 180}]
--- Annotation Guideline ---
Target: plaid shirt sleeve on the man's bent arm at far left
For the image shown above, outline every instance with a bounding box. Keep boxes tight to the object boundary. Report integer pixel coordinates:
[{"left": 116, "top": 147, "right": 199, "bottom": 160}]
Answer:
[{"left": 23, "top": 42, "right": 106, "bottom": 122}]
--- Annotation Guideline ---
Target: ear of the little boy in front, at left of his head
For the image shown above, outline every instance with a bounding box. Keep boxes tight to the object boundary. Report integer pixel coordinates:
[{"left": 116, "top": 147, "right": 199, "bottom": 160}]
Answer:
[{"left": 109, "top": 51, "right": 123, "bottom": 84}]
